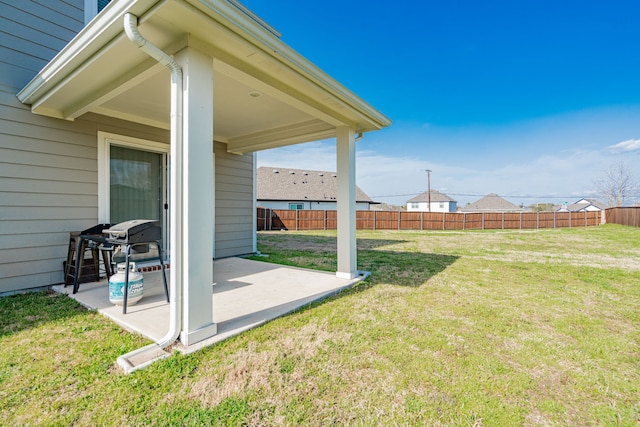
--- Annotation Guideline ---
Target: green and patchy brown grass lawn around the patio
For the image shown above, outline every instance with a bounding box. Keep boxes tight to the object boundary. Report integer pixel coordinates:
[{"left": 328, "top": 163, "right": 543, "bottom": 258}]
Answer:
[{"left": 0, "top": 225, "right": 640, "bottom": 426}]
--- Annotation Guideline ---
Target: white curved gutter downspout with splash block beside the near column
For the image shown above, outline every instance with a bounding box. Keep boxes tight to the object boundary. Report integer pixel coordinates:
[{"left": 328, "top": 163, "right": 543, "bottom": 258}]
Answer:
[{"left": 117, "top": 13, "right": 182, "bottom": 373}]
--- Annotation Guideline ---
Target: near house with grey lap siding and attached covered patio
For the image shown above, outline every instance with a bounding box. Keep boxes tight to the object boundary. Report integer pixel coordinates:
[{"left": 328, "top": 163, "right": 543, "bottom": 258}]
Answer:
[{"left": 0, "top": 0, "right": 390, "bottom": 345}]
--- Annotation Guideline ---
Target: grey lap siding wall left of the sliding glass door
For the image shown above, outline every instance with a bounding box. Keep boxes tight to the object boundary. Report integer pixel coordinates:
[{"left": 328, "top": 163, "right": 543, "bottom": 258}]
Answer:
[{"left": 0, "top": 0, "right": 86, "bottom": 293}]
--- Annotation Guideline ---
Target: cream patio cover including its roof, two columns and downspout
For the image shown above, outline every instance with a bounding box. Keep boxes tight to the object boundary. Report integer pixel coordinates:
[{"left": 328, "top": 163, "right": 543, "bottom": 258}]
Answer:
[{"left": 18, "top": 0, "right": 390, "bottom": 366}]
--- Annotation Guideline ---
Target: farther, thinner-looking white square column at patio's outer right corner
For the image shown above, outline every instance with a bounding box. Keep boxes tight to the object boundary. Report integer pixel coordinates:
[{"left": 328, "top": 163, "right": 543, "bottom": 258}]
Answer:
[{"left": 336, "top": 126, "right": 358, "bottom": 279}]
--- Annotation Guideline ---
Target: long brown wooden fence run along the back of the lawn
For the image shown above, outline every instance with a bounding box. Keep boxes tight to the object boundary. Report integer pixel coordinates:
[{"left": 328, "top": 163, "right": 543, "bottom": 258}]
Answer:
[{"left": 257, "top": 208, "right": 608, "bottom": 230}]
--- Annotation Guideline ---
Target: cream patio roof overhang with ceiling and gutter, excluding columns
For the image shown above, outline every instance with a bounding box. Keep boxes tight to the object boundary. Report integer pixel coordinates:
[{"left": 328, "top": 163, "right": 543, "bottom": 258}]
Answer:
[{"left": 18, "top": 0, "right": 390, "bottom": 153}]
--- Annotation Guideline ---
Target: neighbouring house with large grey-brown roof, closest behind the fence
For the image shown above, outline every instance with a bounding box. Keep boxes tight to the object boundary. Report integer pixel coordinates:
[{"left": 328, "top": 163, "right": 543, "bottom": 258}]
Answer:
[{"left": 256, "top": 167, "right": 376, "bottom": 211}]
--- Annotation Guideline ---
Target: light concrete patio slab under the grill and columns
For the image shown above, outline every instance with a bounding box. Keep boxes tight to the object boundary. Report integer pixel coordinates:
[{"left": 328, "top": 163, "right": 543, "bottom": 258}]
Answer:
[{"left": 54, "top": 258, "right": 366, "bottom": 353}]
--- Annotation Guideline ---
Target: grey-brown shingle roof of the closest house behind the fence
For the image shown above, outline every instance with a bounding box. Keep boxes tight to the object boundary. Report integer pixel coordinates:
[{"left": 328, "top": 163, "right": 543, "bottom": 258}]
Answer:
[{"left": 257, "top": 166, "right": 376, "bottom": 203}]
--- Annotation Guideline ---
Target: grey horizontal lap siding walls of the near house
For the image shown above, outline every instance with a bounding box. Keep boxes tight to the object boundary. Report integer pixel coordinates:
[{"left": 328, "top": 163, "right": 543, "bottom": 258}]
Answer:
[{"left": 0, "top": 0, "right": 254, "bottom": 294}]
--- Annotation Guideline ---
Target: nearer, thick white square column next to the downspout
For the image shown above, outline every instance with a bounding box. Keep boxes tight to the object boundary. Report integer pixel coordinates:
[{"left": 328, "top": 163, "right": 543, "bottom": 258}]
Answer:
[{"left": 172, "top": 47, "right": 217, "bottom": 345}]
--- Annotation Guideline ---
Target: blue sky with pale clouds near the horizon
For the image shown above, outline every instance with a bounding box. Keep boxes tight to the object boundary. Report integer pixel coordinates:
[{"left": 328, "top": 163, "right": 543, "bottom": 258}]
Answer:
[{"left": 242, "top": 0, "right": 640, "bottom": 205}]
